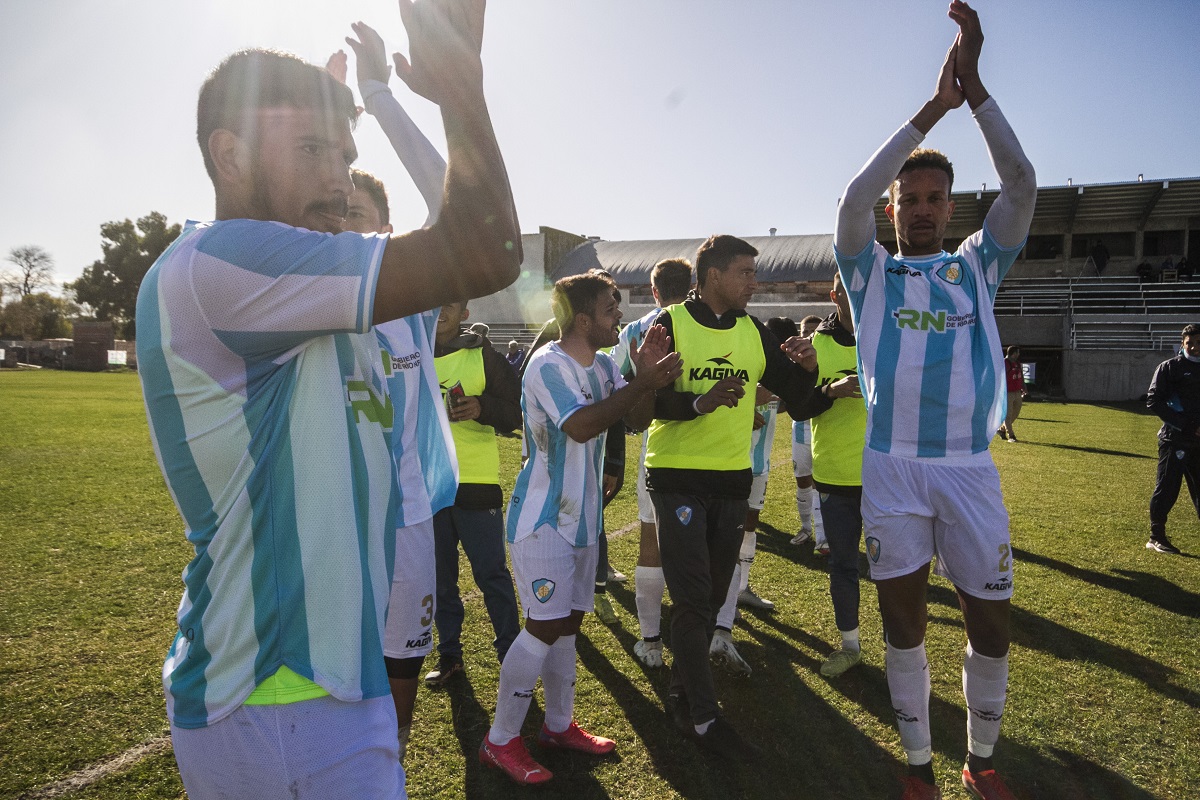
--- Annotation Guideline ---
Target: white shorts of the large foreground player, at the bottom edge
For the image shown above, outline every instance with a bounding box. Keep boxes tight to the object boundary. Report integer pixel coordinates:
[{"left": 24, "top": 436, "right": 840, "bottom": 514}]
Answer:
[{"left": 170, "top": 696, "right": 406, "bottom": 800}]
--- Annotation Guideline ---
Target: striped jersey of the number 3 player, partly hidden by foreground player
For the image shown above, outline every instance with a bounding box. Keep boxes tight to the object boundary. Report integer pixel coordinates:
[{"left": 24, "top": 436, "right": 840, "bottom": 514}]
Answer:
[{"left": 374, "top": 309, "right": 458, "bottom": 528}]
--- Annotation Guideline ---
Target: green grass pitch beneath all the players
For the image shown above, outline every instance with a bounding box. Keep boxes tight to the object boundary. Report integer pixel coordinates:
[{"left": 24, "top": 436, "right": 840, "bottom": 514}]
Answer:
[{"left": 0, "top": 371, "right": 1200, "bottom": 800}]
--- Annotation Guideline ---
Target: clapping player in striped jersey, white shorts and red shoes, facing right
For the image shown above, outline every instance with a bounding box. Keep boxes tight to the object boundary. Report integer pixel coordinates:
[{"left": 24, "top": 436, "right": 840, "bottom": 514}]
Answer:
[{"left": 479, "top": 273, "right": 682, "bottom": 786}]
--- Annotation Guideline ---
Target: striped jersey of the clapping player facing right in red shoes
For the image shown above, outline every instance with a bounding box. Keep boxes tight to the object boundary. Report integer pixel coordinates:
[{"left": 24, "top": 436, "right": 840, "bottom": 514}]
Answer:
[{"left": 508, "top": 342, "right": 625, "bottom": 547}]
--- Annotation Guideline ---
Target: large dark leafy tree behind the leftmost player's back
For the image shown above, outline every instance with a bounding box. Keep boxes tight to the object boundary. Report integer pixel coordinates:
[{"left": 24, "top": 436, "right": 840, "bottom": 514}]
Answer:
[{"left": 67, "top": 211, "right": 180, "bottom": 339}]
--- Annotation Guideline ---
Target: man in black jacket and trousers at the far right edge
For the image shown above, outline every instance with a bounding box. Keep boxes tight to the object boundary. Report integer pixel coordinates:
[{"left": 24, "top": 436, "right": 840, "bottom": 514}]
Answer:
[{"left": 1146, "top": 325, "right": 1200, "bottom": 553}]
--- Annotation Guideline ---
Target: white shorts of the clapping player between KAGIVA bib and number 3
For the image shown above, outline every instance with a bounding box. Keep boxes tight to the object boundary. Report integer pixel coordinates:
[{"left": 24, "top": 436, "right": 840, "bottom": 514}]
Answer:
[{"left": 509, "top": 527, "right": 600, "bottom": 620}]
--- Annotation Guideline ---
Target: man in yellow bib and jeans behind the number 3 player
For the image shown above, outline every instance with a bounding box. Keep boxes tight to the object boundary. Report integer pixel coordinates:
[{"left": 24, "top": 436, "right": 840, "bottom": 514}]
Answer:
[{"left": 425, "top": 302, "right": 521, "bottom": 686}]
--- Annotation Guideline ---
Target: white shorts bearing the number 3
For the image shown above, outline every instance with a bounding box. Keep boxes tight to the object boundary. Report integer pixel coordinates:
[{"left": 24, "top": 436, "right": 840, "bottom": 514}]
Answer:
[{"left": 383, "top": 518, "right": 438, "bottom": 658}]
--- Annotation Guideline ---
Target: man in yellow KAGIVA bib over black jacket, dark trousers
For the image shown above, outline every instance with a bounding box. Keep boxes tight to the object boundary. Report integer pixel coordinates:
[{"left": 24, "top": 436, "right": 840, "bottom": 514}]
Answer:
[{"left": 646, "top": 235, "right": 817, "bottom": 760}]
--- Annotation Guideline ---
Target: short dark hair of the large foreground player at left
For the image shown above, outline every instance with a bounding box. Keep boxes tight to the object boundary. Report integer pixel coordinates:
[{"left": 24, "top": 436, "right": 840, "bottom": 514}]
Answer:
[{"left": 196, "top": 49, "right": 358, "bottom": 180}]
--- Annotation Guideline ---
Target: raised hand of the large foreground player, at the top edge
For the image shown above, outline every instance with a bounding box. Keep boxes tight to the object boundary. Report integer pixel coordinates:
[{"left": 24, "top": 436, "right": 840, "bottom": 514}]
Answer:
[{"left": 392, "top": 0, "right": 485, "bottom": 106}]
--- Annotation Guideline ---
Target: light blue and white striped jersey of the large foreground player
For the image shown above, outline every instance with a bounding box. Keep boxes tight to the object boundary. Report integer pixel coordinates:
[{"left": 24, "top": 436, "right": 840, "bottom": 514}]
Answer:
[{"left": 137, "top": 219, "right": 396, "bottom": 728}]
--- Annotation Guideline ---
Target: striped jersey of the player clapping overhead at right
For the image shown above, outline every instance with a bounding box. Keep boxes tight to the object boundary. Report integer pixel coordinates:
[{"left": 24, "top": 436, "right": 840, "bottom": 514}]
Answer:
[{"left": 834, "top": 227, "right": 1024, "bottom": 461}]
